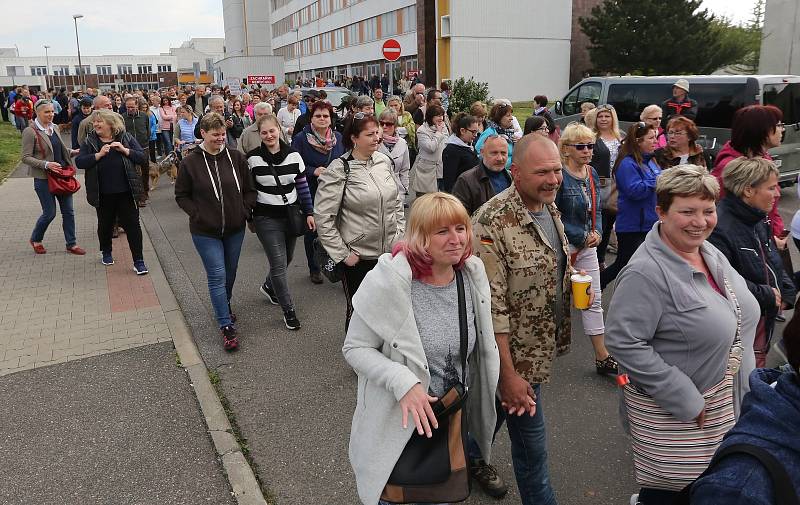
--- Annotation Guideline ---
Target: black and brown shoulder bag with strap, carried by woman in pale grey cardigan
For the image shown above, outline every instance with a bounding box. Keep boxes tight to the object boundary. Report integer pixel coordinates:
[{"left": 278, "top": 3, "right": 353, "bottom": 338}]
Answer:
[{"left": 381, "top": 270, "right": 470, "bottom": 503}]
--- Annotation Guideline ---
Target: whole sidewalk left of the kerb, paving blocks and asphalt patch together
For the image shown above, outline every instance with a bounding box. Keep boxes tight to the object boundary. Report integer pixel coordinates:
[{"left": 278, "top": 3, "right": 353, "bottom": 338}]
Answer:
[{"left": 0, "top": 178, "right": 241, "bottom": 505}]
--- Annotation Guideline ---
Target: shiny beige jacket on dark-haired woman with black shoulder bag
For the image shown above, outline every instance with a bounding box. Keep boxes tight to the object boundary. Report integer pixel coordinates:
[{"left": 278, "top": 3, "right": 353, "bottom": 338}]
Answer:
[{"left": 314, "top": 152, "right": 406, "bottom": 263}]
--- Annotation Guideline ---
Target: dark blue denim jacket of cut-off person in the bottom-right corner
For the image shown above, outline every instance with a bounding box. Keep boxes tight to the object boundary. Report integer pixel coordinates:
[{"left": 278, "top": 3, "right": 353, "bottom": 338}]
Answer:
[{"left": 691, "top": 368, "right": 800, "bottom": 505}]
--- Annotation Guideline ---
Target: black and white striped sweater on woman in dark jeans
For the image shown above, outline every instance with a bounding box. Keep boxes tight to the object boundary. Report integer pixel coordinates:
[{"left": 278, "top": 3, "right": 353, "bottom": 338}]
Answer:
[{"left": 247, "top": 140, "right": 314, "bottom": 218}]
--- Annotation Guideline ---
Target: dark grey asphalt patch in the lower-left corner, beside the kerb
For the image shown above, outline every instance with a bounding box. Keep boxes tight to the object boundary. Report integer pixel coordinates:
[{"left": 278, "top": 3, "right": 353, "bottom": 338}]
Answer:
[{"left": 0, "top": 343, "right": 235, "bottom": 505}]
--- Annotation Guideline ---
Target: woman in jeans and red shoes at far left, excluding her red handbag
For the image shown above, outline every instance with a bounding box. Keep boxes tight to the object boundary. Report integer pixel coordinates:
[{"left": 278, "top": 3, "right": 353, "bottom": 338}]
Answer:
[{"left": 22, "top": 100, "right": 86, "bottom": 256}]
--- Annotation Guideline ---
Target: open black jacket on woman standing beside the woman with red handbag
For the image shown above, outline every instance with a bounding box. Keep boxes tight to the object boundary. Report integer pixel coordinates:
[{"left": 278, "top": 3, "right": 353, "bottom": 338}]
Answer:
[{"left": 75, "top": 132, "right": 147, "bottom": 207}]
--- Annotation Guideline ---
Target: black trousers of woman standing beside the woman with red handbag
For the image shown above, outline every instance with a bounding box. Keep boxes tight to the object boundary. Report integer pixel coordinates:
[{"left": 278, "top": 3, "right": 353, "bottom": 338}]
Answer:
[{"left": 97, "top": 192, "right": 144, "bottom": 261}]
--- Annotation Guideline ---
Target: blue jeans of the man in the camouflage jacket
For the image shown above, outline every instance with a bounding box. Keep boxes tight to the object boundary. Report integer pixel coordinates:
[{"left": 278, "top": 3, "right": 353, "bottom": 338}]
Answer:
[{"left": 467, "top": 384, "right": 556, "bottom": 505}]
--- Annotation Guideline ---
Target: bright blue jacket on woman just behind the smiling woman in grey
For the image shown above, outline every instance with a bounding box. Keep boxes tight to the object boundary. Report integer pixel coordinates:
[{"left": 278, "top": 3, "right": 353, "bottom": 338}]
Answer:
[{"left": 614, "top": 155, "right": 661, "bottom": 233}]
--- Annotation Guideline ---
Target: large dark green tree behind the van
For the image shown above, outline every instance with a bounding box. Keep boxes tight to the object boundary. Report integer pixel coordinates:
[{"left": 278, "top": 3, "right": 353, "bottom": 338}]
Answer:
[{"left": 579, "top": 0, "right": 742, "bottom": 75}]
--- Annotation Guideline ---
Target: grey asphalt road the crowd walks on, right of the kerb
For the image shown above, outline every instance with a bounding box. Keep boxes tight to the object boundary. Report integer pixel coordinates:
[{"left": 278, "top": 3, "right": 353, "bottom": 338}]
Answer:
[{"left": 143, "top": 170, "right": 797, "bottom": 505}]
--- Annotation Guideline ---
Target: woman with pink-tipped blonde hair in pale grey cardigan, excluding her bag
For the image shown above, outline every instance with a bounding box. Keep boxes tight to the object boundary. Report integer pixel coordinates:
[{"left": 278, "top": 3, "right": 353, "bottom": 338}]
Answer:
[{"left": 342, "top": 193, "right": 500, "bottom": 505}]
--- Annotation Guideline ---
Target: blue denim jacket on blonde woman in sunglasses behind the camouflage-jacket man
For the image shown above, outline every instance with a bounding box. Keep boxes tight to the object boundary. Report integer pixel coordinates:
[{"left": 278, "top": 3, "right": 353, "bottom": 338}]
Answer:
[{"left": 556, "top": 167, "right": 603, "bottom": 249}]
